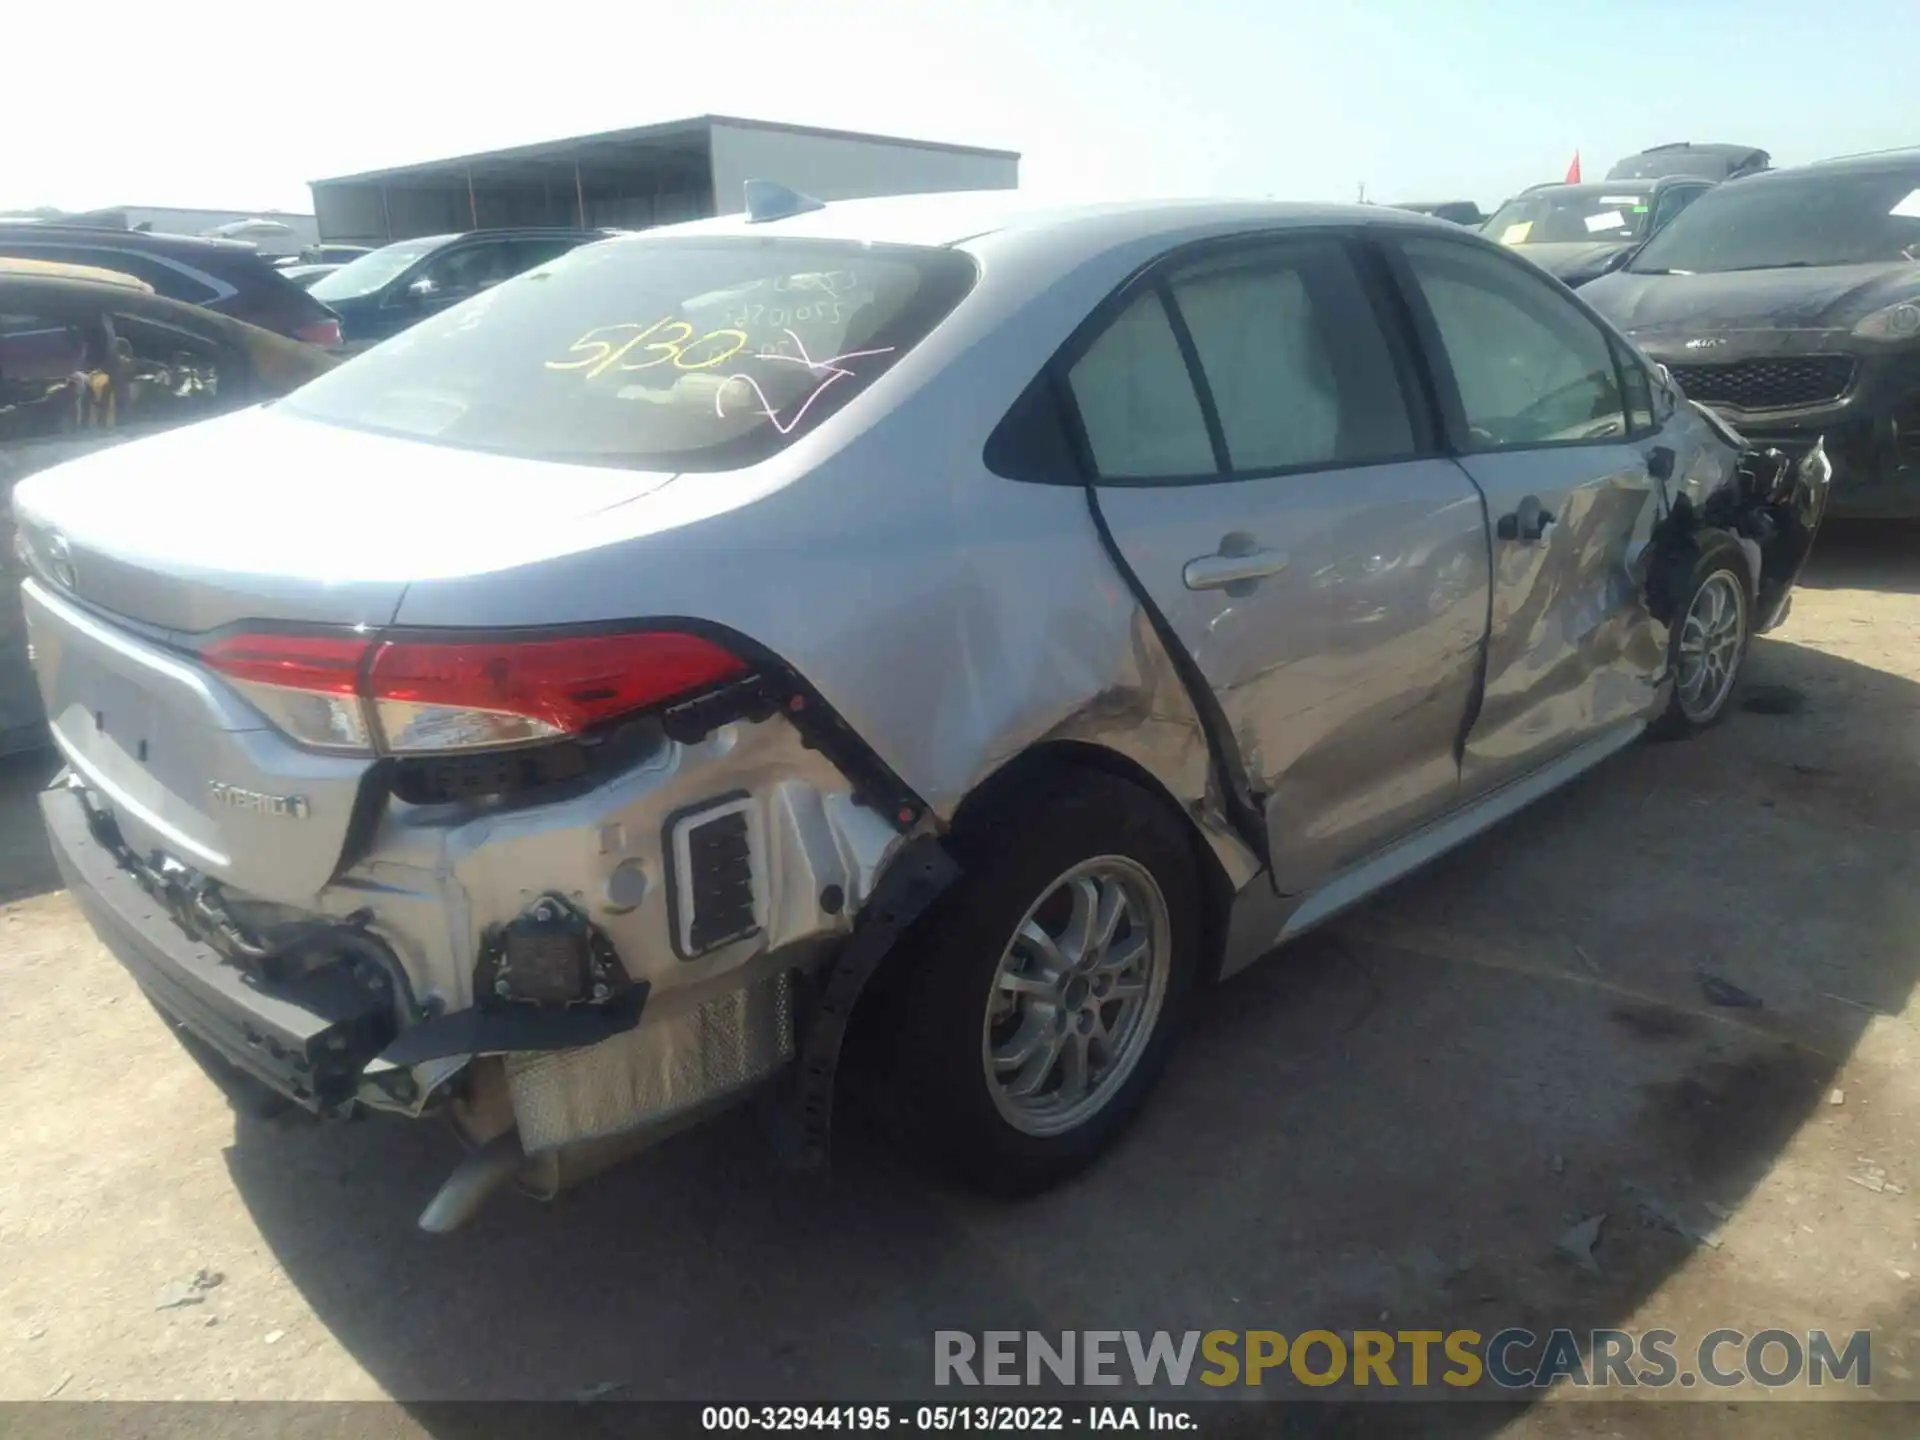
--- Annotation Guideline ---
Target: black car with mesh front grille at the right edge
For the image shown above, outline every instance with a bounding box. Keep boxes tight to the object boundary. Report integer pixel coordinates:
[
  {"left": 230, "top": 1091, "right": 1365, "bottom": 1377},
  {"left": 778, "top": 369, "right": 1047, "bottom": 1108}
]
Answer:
[{"left": 1580, "top": 150, "right": 1920, "bottom": 518}]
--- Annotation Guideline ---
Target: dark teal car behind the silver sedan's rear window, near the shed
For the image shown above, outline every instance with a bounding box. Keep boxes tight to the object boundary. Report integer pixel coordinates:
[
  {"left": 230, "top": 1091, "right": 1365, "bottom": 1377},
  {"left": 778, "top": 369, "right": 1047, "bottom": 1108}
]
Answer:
[{"left": 311, "top": 228, "right": 607, "bottom": 346}]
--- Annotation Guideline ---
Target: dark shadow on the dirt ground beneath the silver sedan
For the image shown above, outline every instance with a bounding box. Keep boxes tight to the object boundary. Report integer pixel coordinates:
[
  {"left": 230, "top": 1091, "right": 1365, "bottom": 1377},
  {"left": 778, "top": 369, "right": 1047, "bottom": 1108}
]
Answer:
[{"left": 131, "top": 537, "right": 1920, "bottom": 1434}]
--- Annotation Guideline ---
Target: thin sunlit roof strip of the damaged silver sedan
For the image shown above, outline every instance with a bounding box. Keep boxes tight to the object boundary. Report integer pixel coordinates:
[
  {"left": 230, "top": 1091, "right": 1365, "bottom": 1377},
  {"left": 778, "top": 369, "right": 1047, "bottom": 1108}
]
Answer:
[{"left": 614, "top": 190, "right": 1459, "bottom": 246}]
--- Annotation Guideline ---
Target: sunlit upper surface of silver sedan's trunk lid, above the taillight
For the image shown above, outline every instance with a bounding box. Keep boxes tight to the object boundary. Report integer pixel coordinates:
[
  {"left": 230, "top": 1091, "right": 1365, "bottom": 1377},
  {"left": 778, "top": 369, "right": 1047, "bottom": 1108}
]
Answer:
[{"left": 13, "top": 407, "right": 672, "bottom": 634}]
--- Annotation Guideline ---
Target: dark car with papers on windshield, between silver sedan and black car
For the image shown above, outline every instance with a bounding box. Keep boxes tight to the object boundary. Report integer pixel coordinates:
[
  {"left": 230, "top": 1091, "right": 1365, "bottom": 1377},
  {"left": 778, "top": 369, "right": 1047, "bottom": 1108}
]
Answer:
[{"left": 1482, "top": 177, "right": 1713, "bottom": 286}]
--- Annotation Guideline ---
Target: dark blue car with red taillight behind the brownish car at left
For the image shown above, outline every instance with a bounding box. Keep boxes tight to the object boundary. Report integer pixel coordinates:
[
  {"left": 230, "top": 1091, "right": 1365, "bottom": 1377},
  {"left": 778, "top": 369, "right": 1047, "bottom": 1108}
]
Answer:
[{"left": 0, "top": 221, "right": 340, "bottom": 346}]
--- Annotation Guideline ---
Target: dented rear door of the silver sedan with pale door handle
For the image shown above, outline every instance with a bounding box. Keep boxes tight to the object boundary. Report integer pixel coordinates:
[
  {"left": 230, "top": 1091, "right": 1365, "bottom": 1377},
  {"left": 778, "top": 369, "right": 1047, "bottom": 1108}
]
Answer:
[{"left": 1068, "top": 234, "right": 1488, "bottom": 895}]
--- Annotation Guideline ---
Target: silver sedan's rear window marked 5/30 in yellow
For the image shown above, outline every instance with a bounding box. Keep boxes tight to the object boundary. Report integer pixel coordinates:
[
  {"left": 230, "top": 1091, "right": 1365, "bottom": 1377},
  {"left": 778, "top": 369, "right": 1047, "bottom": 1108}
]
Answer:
[{"left": 280, "top": 238, "right": 973, "bottom": 470}]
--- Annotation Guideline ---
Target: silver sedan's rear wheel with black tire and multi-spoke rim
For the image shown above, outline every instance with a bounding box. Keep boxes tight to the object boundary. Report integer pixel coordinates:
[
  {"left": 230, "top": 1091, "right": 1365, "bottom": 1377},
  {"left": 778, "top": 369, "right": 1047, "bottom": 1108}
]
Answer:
[{"left": 893, "top": 768, "right": 1204, "bottom": 1196}]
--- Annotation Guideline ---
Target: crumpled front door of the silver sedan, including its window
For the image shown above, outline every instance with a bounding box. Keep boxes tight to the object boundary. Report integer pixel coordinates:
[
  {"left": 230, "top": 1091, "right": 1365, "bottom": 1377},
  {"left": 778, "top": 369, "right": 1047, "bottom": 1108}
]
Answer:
[{"left": 1396, "top": 236, "right": 1663, "bottom": 799}]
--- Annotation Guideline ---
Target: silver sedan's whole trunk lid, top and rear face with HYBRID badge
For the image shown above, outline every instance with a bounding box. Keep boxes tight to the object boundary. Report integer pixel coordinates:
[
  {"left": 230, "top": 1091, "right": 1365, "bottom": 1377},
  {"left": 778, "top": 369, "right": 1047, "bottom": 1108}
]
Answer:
[{"left": 13, "top": 409, "right": 672, "bottom": 904}]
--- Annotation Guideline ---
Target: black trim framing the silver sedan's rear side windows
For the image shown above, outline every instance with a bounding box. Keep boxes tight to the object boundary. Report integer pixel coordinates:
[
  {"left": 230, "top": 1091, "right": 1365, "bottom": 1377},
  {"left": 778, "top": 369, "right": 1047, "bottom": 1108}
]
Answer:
[{"left": 985, "top": 225, "right": 1450, "bottom": 488}]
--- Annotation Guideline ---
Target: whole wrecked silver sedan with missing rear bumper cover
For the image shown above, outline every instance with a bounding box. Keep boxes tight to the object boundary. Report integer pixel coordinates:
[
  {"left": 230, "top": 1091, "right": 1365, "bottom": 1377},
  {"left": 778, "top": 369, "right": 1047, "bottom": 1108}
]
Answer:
[{"left": 15, "top": 186, "right": 1828, "bottom": 1229}]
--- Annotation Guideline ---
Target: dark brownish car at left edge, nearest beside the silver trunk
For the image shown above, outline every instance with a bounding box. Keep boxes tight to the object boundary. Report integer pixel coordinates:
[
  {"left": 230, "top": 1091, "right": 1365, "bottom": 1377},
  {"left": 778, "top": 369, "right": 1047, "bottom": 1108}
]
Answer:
[{"left": 0, "top": 257, "right": 334, "bottom": 755}]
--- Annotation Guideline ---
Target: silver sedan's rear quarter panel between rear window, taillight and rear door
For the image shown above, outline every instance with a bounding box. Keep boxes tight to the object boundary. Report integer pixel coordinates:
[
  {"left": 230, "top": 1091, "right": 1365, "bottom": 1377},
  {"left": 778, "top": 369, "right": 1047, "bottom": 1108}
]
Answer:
[{"left": 385, "top": 223, "right": 1274, "bottom": 902}]
